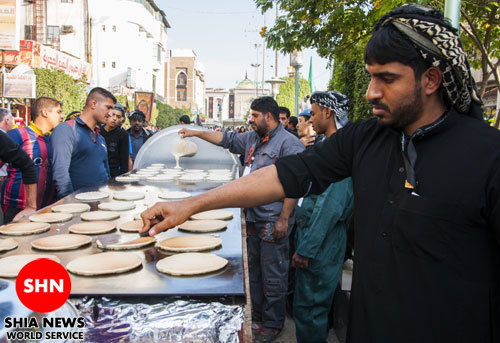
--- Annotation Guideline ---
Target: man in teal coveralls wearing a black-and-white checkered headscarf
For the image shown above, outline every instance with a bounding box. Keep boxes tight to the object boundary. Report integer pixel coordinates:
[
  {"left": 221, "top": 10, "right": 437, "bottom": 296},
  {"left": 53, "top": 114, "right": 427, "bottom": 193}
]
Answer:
[{"left": 292, "top": 91, "right": 353, "bottom": 343}]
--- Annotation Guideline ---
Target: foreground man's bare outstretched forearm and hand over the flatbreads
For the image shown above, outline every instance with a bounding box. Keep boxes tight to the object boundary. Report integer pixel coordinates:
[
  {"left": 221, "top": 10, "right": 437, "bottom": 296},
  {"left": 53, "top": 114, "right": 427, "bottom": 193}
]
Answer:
[{"left": 141, "top": 165, "right": 285, "bottom": 236}]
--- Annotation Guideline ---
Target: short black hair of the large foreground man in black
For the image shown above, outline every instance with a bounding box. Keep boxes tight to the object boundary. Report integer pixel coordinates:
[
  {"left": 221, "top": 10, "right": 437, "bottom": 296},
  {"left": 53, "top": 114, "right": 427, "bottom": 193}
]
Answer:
[{"left": 364, "top": 24, "right": 430, "bottom": 80}]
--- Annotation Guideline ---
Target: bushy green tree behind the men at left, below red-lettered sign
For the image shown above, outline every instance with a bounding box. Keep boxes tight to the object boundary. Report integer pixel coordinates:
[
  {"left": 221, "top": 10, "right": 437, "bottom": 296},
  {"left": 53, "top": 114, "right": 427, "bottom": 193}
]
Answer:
[{"left": 34, "top": 68, "right": 87, "bottom": 116}]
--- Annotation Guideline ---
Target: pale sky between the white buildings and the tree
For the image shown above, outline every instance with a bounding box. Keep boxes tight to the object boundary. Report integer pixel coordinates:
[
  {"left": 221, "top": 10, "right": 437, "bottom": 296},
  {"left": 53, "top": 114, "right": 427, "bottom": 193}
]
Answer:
[{"left": 155, "top": 0, "right": 331, "bottom": 90}]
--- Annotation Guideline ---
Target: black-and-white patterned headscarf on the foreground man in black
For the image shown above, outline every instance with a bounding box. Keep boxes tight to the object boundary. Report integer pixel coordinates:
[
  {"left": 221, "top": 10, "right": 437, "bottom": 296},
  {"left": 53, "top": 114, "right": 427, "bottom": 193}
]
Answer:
[{"left": 375, "top": 4, "right": 482, "bottom": 115}]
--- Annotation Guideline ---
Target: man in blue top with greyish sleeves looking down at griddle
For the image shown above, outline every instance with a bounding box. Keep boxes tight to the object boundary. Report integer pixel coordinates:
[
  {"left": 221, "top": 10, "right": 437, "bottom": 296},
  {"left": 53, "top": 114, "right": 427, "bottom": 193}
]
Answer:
[{"left": 50, "top": 87, "right": 116, "bottom": 198}]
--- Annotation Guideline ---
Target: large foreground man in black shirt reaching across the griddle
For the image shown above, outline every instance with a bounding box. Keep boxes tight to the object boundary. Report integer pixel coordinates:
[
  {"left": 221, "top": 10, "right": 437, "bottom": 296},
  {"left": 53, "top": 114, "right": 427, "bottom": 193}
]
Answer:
[{"left": 142, "top": 5, "right": 500, "bottom": 343}]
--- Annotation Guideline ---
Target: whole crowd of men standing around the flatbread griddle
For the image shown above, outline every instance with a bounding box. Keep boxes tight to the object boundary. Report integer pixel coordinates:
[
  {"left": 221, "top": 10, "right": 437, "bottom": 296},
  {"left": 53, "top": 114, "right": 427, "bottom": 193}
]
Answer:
[{"left": 0, "top": 4, "right": 500, "bottom": 343}]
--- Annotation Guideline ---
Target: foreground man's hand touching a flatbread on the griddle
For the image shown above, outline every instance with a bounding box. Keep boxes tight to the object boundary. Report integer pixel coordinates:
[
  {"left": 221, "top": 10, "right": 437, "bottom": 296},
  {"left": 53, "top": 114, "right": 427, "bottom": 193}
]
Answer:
[{"left": 139, "top": 201, "right": 190, "bottom": 236}]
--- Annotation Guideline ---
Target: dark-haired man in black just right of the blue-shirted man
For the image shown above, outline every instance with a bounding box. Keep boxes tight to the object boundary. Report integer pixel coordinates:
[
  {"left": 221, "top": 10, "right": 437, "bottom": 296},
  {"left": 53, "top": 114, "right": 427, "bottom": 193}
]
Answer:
[{"left": 101, "top": 103, "right": 129, "bottom": 177}]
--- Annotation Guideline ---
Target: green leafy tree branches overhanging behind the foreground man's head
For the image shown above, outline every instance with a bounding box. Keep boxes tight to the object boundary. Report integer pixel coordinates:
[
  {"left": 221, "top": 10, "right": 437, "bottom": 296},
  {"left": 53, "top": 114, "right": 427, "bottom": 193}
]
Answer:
[{"left": 255, "top": 0, "right": 500, "bottom": 124}]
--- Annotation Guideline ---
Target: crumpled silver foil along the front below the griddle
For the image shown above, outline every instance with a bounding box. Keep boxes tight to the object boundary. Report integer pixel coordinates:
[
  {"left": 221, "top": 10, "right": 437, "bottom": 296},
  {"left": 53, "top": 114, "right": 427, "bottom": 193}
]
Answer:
[{"left": 71, "top": 297, "right": 244, "bottom": 343}]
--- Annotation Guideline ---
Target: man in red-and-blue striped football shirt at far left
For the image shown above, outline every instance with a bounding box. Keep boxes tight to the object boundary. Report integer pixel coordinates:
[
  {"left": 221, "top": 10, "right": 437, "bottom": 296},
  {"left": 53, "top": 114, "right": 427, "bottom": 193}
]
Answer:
[{"left": 1, "top": 97, "right": 63, "bottom": 223}]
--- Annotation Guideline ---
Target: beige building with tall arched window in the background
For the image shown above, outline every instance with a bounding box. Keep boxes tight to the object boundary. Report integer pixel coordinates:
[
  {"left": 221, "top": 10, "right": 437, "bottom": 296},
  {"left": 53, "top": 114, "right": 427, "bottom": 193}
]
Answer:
[{"left": 165, "top": 49, "right": 205, "bottom": 114}]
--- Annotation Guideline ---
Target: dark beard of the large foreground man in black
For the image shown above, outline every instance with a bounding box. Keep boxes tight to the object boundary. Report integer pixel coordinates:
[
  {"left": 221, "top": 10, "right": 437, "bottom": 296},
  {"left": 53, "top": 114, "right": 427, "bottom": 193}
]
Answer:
[{"left": 371, "top": 82, "right": 423, "bottom": 129}]
